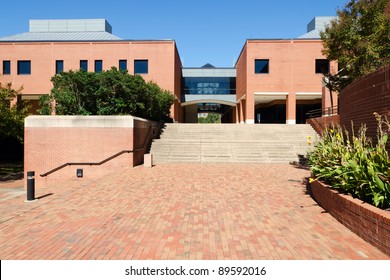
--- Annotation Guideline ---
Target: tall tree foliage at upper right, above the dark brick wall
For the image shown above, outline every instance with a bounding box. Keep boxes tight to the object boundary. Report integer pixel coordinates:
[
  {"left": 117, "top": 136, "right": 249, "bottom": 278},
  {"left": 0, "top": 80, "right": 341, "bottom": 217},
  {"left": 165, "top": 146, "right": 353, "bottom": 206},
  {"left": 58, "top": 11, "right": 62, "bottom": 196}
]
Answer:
[{"left": 321, "top": 0, "right": 390, "bottom": 90}]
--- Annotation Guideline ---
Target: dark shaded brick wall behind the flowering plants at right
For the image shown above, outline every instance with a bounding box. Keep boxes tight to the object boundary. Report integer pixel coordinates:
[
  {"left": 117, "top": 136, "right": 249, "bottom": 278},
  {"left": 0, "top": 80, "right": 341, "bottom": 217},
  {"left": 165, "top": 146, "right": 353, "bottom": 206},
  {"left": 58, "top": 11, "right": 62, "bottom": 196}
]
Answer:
[{"left": 339, "top": 65, "right": 390, "bottom": 141}]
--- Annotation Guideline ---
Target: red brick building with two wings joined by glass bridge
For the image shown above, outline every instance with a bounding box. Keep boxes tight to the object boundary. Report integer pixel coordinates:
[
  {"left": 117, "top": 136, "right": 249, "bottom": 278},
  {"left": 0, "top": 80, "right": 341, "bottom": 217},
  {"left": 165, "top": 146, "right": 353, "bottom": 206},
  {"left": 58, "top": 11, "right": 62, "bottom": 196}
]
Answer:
[{"left": 0, "top": 17, "right": 337, "bottom": 124}]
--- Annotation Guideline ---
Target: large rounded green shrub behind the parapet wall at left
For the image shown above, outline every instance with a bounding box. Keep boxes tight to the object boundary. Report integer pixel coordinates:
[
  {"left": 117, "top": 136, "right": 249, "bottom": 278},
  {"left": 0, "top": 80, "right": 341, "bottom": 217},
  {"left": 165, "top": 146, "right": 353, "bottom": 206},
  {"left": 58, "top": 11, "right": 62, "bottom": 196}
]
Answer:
[{"left": 40, "top": 67, "right": 173, "bottom": 120}]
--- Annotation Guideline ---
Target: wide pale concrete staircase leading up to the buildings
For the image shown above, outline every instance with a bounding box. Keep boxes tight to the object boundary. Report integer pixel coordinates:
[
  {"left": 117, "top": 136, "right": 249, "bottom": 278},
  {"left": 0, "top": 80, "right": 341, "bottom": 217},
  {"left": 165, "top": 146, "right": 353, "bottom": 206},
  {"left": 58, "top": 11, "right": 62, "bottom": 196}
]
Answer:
[{"left": 150, "top": 124, "right": 316, "bottom": 164}]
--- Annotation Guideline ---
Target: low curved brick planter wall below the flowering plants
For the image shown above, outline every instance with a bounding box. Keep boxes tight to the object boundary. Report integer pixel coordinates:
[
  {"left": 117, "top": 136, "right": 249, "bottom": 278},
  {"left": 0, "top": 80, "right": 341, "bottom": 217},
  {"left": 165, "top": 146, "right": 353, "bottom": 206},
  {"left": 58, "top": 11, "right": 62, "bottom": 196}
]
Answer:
[{"left": 311, "top": 181, "right": 390, "bottom": 255}]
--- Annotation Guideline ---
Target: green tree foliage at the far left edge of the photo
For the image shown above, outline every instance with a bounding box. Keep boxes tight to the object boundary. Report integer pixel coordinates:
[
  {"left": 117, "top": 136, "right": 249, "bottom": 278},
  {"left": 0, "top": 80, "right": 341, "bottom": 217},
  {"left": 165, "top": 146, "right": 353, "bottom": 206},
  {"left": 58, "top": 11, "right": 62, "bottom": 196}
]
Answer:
[{"left": 0, "top": 83, "right": 29, "bottom": 143}]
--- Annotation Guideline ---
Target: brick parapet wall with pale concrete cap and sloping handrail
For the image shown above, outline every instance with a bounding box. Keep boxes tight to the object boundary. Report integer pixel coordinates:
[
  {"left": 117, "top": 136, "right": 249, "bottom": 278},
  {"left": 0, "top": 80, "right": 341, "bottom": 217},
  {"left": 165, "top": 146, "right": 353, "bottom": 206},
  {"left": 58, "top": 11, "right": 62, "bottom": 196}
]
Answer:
[{"left": 24, "top": 116, "right": 155, "bottom": 187}]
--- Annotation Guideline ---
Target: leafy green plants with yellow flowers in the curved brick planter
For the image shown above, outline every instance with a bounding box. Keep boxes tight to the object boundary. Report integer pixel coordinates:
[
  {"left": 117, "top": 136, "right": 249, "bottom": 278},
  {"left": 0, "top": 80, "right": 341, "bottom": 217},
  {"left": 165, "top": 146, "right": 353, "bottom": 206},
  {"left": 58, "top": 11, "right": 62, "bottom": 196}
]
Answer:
[{"left": 308, "top": 114, "right": 390, "bottom": 209}]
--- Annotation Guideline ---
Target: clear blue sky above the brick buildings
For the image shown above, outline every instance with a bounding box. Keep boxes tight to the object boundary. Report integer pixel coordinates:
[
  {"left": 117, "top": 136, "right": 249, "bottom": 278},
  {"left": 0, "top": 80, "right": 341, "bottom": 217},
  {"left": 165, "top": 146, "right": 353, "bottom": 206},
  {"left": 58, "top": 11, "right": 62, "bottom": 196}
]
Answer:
[{"left": 0, "top": 0, "right": 348, "bottom": 67}]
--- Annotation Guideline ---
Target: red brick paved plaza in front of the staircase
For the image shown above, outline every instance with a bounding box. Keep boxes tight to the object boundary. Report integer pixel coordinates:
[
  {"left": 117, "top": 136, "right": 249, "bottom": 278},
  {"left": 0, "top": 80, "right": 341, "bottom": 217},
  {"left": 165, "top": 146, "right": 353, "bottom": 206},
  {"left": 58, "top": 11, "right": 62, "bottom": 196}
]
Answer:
[{"left": 0, "top": 164, "right": 389, "bottom": 260}]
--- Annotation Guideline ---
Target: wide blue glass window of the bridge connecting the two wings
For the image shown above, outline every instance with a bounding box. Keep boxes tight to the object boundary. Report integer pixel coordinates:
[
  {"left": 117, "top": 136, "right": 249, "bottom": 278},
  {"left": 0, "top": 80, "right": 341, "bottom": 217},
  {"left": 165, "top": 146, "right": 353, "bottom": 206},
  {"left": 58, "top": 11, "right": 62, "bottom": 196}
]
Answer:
[{"left": 183, "top": 77, "right": 236, "bottom": 94}]
